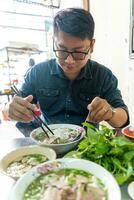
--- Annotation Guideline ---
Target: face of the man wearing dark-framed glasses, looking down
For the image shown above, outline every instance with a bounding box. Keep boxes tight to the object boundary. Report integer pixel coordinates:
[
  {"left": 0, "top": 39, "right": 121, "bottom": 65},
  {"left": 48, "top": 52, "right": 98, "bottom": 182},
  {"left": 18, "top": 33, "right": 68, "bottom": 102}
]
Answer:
[{"left": 54, "top": 31, "right": 94, "bottom": 78}]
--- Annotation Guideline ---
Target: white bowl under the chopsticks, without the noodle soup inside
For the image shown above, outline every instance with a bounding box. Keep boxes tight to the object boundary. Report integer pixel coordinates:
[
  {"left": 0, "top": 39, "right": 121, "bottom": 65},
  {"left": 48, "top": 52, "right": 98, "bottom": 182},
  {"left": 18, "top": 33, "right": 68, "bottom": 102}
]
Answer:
[{"left": 30, "top": 124, "right": 86, "bottom": 155}]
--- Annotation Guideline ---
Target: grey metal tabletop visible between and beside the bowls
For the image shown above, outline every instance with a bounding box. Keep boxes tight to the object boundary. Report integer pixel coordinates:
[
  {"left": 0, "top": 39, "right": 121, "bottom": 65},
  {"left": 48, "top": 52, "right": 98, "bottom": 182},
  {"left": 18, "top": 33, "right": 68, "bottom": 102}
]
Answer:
[{"left": 0, "top": 137, "right": 132, "bottom": 200}]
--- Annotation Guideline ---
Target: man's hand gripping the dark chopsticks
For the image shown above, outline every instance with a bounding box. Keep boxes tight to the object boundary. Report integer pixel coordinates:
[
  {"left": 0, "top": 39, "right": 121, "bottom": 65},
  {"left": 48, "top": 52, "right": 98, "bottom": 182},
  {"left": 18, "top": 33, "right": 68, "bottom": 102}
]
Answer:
[{"left": 4, "top": 95, "right": 37, "bottom": 122}]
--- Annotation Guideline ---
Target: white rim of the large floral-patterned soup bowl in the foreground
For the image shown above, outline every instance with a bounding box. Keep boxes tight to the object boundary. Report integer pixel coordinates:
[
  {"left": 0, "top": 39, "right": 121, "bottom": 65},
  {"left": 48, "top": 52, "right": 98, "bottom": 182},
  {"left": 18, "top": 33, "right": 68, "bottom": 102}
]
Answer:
[{"left": 9, "top": 158, "right": 121, "bottom": 200}]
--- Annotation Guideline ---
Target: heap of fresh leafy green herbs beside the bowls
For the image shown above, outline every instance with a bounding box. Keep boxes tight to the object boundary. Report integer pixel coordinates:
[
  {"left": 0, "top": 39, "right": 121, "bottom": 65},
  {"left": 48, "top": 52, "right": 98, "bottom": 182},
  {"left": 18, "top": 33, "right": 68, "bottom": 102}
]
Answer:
[{"left": 65, "top": 122, "right": 134, "bottom": 185}]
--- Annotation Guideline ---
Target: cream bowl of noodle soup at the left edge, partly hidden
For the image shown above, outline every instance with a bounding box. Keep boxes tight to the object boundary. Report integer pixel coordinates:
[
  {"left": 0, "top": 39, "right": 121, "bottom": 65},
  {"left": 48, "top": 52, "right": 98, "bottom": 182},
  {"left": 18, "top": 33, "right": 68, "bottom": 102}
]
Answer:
[{"left": 0, "top": 145, "right": 56, "bottom": 180}]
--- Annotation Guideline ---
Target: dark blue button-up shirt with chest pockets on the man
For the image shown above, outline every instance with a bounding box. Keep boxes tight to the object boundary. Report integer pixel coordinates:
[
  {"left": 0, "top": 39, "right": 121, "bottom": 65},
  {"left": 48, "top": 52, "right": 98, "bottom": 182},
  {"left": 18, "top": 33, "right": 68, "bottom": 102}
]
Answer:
[{"left": 21, "top": 59, "right": 127, "bottom": 125}]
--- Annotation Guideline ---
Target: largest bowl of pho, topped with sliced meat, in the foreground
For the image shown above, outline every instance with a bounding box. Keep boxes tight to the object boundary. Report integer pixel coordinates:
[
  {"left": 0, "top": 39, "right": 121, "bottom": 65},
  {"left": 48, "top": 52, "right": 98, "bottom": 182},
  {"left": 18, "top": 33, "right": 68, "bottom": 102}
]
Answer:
[{"left": 9, "top": 158, "right": 121, "bottom": 200}]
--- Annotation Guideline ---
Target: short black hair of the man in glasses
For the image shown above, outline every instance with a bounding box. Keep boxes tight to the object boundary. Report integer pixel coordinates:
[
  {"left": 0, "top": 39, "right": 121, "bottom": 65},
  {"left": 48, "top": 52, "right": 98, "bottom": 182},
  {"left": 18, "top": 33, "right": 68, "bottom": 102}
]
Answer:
[{"left": 53, "top": 8, "right": 95, "bottom": 40}]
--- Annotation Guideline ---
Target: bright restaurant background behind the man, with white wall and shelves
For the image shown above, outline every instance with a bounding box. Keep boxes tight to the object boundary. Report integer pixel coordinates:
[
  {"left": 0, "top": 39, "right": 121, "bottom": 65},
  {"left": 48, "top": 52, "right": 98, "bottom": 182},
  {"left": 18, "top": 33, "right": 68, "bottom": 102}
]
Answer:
[{"left": 0, "top": 0, "right": 134, "bottom": 130}]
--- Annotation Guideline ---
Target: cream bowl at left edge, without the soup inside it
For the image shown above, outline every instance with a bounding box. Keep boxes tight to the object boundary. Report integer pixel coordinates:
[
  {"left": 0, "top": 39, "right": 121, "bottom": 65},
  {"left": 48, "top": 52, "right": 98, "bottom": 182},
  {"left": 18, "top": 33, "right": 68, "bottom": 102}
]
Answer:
[{"left": 0, "top": 145, "right": 56, "bottom": 180}]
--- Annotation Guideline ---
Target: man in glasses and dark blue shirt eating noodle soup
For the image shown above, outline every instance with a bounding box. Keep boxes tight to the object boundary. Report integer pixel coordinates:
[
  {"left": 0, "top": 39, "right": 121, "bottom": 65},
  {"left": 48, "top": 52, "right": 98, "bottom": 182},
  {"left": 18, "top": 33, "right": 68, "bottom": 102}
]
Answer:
[{"left": 6, "top": 8, "right": 129, "bottom": 134}]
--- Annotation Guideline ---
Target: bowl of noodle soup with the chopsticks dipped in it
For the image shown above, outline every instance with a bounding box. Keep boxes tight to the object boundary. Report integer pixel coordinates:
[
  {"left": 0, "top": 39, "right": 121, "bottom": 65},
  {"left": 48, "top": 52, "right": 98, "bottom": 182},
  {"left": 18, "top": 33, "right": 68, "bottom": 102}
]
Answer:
[{"left": 30, "top": 124, "right": 86, "bottom": 154}]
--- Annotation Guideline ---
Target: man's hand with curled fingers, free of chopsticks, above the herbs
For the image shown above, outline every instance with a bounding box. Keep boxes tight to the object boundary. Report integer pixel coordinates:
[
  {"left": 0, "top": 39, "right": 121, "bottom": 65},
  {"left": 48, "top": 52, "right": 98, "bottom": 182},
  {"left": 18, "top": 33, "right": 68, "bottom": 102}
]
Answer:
[{"left": 86, "top": 97, "right": 113, "bottom": 123}]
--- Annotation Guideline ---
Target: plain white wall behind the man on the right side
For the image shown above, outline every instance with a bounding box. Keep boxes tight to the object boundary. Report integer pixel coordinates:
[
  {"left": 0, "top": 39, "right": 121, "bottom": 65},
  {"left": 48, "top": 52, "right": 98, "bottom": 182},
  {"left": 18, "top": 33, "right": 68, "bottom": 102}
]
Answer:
[{"left": 90, "top": 0, "right": 134, "bottom": 124}]
